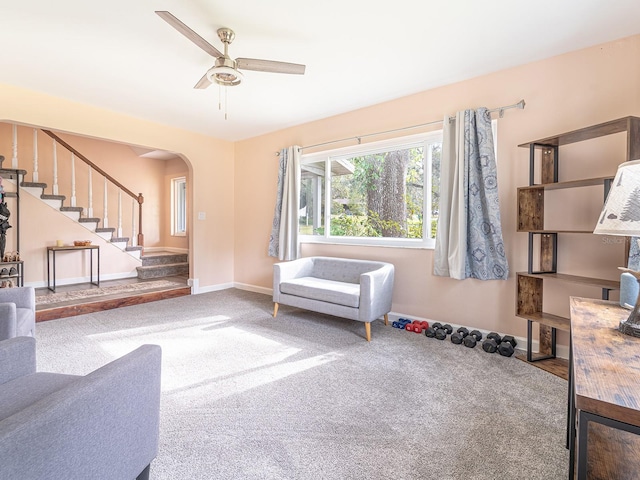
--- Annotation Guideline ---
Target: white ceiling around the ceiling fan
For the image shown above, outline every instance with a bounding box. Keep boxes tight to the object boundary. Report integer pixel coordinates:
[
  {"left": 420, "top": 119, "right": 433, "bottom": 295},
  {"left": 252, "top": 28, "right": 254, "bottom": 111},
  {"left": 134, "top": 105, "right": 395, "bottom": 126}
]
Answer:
[{"left": 0, "top": 0, "right": 640, "bottom": 141}]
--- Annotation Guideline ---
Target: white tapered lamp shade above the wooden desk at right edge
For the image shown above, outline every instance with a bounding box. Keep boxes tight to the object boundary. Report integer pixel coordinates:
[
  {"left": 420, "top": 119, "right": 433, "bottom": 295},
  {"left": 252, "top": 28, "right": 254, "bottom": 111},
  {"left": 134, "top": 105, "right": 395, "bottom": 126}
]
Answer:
[{"left": 593, "top": 160, "right": 640, "bottom": 237}]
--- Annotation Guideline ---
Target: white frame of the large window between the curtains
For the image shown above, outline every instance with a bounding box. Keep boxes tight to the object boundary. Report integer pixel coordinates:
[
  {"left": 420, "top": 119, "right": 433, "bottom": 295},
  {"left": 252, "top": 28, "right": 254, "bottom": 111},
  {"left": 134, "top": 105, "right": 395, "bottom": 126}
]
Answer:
[{"left": 299, "top": 129, "right": 442, "bottom": 249}]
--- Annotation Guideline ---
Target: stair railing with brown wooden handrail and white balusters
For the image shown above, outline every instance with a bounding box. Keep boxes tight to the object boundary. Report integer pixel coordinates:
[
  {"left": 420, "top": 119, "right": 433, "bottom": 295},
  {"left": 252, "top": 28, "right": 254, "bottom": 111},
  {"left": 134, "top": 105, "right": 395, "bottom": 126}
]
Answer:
[{"left": 39, "top": 129, "right": 144, "bottom": 247}]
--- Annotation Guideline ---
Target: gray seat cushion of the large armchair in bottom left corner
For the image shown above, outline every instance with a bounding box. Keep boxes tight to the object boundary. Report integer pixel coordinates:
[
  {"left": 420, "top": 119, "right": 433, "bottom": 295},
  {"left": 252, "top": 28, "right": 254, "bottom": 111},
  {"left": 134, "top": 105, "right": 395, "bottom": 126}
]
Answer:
[{"left": 0, "top": 372, "right": 81, "bottom": 420}]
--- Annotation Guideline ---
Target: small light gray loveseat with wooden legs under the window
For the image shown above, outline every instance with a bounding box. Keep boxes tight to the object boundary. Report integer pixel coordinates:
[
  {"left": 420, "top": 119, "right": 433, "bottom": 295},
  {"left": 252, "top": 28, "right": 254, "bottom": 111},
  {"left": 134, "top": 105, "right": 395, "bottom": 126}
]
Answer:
[{"left": 273, "top": 257, "right": 394, "bottom": 341}]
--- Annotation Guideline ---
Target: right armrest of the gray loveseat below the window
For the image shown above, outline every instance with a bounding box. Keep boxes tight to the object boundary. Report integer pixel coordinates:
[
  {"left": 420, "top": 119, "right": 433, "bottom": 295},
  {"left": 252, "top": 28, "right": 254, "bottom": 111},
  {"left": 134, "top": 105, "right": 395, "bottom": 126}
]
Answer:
[{"left": 358, "top": 263, "right": 394, "bottom": 322}]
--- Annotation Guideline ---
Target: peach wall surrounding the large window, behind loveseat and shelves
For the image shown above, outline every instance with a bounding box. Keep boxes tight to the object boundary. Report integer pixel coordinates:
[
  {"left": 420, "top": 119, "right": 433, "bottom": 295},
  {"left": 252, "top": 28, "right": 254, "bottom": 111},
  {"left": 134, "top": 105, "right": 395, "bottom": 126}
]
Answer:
[{"left": 234, "top": 36, "right": 640, "bottom": 341}]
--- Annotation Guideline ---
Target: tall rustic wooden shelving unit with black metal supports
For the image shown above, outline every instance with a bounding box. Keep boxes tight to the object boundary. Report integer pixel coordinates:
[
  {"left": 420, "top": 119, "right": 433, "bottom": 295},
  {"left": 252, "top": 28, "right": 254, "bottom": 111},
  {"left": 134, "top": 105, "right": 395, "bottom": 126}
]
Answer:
[{"left": 516, "top": 117, "right": 640, "bottom": 368}]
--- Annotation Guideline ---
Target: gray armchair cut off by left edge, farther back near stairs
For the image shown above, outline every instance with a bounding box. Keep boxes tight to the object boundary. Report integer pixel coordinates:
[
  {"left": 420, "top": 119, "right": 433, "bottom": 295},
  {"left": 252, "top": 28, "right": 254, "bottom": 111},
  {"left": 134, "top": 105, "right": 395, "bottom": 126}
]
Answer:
[{"left": 0, "top": 287, "right": 36, "bottom": 340}]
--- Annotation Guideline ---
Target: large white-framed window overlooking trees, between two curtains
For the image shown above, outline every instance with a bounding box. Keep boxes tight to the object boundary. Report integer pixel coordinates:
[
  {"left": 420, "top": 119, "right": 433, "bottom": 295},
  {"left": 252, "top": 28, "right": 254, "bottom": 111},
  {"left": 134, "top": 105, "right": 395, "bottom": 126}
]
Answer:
[{"left": 299, "top": 131, "right": 442, "bottom": 247}]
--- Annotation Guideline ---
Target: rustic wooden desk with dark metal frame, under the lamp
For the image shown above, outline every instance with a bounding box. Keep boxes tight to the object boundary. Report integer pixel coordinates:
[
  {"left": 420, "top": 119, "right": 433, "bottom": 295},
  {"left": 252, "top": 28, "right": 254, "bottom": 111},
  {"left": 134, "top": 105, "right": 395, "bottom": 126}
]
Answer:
[{"left": 567, "top": 297, "right": 640, "bottom": 480}]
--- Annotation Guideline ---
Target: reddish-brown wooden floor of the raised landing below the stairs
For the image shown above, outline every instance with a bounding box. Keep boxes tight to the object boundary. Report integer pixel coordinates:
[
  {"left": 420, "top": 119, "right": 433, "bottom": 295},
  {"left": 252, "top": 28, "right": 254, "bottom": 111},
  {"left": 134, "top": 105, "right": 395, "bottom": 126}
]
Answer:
[{"left": 36, "top": 276, "right": 191, "bottom": 322}]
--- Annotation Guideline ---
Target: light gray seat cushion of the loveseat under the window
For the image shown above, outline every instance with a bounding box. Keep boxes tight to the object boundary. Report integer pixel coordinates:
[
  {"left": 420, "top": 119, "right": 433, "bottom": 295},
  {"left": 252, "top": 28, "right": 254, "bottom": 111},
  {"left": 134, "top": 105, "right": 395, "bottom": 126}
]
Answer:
[{"left": 280, "top": 277, "right": 360, "bottom": 308}]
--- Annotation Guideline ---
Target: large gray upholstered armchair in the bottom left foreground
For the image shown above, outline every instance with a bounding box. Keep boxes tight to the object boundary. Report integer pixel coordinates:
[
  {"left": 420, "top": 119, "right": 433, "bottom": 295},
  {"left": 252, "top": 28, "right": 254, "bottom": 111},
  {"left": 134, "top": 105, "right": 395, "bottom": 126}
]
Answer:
[{"left": 0, "top": 337, "right": 161, "bottom": 480}]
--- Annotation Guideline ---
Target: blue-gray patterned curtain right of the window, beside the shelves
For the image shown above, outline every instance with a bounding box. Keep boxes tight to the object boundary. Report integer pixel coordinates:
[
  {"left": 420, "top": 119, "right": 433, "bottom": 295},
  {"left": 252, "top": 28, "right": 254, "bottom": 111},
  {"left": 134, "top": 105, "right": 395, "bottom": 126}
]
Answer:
[{"left": 434, "top": 108, "right": 509, "bottom": 280}]
